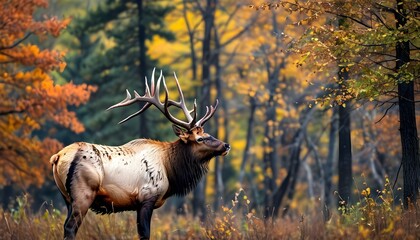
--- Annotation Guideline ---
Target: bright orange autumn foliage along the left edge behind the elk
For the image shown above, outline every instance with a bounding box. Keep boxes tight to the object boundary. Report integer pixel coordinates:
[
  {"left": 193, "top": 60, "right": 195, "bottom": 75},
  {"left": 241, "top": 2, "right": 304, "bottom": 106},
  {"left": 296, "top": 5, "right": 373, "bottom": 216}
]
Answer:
[{"left": 0, "top": 0, "right": 96, "bottom": 187}]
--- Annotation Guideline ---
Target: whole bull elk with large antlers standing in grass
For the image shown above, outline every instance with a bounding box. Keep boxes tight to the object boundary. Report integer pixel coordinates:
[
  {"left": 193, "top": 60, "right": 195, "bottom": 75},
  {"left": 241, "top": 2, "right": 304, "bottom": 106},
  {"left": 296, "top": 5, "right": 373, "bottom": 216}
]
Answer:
[{"left": 50, "top": 70, "right": 230, "bottom": 239}]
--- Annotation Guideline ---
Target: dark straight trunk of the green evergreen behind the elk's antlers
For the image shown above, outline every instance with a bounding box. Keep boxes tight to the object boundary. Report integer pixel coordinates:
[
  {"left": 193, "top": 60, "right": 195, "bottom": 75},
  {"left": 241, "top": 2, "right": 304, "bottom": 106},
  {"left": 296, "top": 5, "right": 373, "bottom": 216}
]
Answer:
[{"left": 137, "top": 0, "right": 149, "bottom": 138}]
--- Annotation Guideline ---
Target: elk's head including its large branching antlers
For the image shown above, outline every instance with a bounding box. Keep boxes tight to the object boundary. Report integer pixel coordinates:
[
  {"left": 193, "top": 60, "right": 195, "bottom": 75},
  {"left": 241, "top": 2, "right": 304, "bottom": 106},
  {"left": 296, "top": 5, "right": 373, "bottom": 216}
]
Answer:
[{"left": 107, "top": 69, "right": 230, "bottom": 159}]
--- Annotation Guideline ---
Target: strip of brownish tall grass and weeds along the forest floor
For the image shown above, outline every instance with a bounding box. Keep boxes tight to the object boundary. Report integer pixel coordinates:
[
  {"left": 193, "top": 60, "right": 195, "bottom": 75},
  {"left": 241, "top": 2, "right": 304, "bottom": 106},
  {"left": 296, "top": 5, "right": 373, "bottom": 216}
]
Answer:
[{"left": 0, "top": 180, "right": 420, "bottom": 240}]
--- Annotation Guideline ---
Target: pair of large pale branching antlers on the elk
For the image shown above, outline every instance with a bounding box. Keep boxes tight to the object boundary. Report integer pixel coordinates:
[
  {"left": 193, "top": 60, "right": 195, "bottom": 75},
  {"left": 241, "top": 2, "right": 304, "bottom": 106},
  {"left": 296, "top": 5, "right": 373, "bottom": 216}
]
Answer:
[{"left": 107, "top": 69, "right": 219, "bottom": 130}]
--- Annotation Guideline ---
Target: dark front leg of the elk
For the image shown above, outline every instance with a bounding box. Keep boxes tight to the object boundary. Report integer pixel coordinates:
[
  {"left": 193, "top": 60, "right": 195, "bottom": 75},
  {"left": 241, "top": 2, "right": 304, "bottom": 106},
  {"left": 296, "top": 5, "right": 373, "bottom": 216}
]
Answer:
[{"left": 137, "top": 197, "right": 157, "bottom": 240}]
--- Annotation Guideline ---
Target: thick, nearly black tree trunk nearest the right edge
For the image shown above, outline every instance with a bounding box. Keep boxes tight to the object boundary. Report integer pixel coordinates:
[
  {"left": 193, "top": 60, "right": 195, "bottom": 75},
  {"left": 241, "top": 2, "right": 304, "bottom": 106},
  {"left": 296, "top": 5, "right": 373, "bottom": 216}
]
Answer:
[{"left": 395, "top": 0, "right": 420, "bottom": 209}]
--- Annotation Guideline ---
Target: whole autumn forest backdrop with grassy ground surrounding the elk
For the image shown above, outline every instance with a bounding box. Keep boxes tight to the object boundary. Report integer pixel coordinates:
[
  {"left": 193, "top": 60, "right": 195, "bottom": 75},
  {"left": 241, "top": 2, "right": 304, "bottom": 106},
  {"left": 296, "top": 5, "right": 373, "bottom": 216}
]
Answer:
[{"left": 0, "top": 0, "right": 420, "bottom": 239}]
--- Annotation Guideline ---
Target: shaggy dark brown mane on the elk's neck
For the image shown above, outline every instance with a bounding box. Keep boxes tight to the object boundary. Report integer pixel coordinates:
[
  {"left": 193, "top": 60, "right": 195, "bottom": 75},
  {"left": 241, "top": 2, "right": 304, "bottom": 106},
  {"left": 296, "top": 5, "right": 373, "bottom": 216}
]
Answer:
[{"left": 164, "top": 140, "right": 213, "bottom": 198}]
